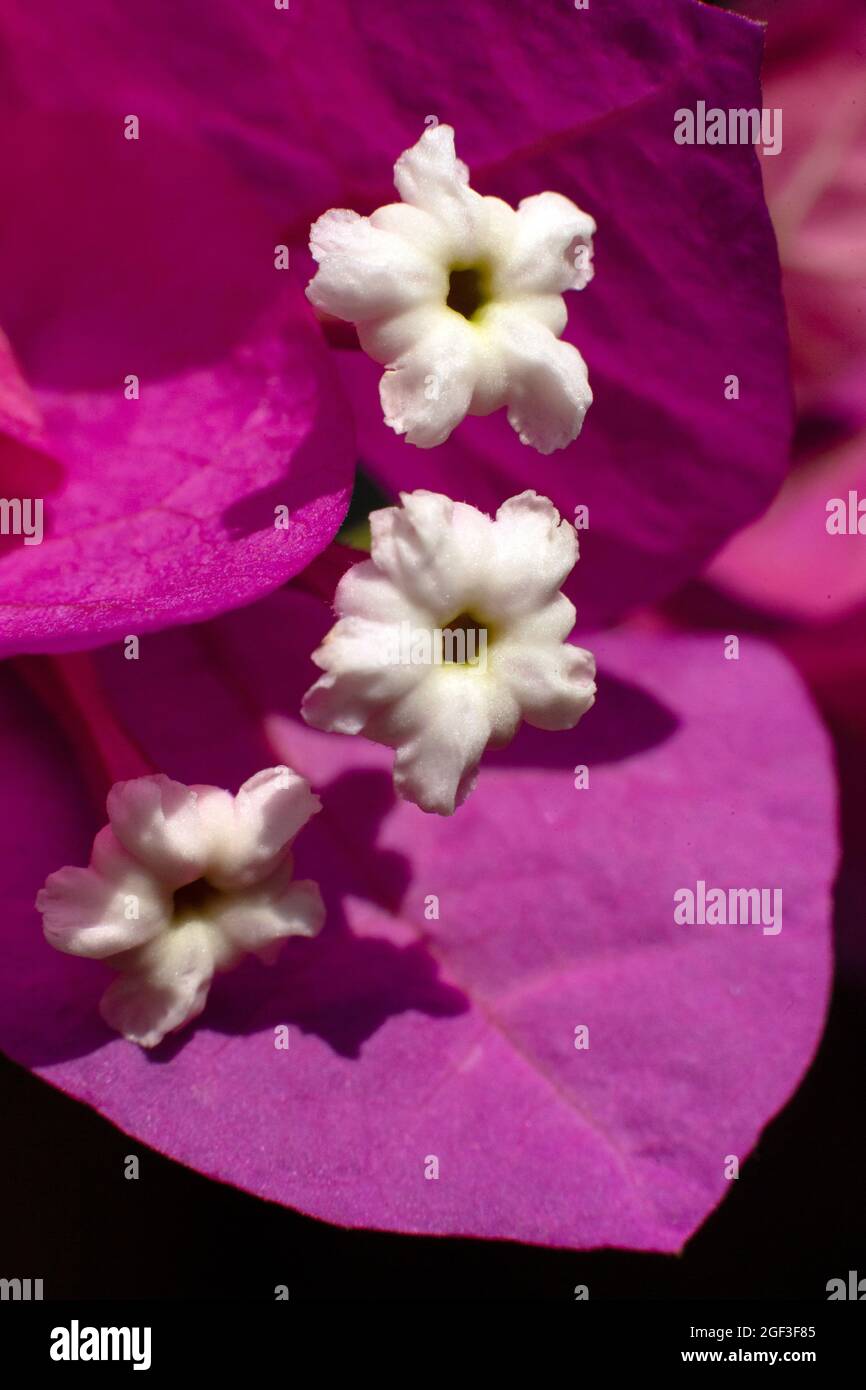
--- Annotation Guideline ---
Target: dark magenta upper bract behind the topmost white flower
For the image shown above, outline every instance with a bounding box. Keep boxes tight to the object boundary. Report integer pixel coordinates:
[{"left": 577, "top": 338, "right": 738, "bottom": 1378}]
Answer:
[{"left": 0, "top": 0, "right": 791, "bottom": 624}]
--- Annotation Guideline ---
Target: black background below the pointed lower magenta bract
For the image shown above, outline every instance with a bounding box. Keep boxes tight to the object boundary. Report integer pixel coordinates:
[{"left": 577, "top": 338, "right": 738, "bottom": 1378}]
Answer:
[{"left": 0, "top": 967, "right": 866, "bottom": 1301}]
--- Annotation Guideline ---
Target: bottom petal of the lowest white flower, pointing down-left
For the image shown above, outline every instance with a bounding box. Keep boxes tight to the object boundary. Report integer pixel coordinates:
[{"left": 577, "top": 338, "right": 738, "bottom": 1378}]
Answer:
[{"left": 99, "top": 924, "right": 214, "bottom": 1048}]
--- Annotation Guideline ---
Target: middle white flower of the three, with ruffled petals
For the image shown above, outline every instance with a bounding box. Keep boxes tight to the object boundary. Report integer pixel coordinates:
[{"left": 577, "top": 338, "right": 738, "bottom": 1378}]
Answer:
[{"left": 302, "top": 492, "right": 595, "bottom": 816}]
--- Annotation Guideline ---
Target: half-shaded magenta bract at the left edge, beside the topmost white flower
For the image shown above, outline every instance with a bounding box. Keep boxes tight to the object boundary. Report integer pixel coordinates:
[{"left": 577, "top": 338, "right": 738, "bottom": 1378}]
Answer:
[{"left": 0, "top": 69, "right": 356, "bottom": 655}]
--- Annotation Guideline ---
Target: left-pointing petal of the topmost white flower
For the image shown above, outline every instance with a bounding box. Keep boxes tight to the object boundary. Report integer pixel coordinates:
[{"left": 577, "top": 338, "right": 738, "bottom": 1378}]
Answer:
[{"left": 307, "top": 209, "right": 448, "bottom": 322}]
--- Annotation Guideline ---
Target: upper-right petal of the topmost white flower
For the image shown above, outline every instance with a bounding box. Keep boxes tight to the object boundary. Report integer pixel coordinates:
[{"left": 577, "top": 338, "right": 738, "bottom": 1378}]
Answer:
[{"left": 496, "top": 193, "right": 595, "bottom": 299}]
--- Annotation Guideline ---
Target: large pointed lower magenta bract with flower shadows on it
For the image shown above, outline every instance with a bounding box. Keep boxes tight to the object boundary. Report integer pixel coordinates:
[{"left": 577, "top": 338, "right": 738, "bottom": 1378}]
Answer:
[{"left": 0, "top": 589, "right": 835, "bottom": 1251}]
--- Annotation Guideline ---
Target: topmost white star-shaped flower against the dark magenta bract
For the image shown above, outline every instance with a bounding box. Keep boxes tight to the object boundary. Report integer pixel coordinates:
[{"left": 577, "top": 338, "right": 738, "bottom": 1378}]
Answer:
[{"left": 307, "top": 125, "right": 595, "bottom": 453}]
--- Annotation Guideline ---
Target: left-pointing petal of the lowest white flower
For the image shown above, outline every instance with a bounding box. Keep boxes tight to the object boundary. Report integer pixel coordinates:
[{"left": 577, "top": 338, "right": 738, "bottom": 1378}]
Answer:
[{"left": 36, "top": 827, "right": 171, "bottom": 958}]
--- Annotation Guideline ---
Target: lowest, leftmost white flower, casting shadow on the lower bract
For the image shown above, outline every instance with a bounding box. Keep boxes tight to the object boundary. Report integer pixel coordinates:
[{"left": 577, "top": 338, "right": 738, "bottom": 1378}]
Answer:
[{"left": 36, "top": 767, "right": 325, "bottom": 1047}]
